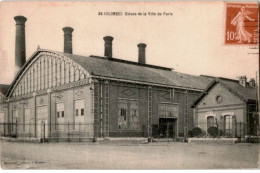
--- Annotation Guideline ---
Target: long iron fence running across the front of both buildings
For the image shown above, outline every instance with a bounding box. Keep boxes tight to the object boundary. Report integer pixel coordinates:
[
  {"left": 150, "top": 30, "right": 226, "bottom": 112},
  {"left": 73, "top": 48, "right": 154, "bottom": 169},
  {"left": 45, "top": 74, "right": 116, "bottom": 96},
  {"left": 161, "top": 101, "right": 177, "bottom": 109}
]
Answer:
[{"left": 0, "top": 121, "right": 260, "bottom": 141}]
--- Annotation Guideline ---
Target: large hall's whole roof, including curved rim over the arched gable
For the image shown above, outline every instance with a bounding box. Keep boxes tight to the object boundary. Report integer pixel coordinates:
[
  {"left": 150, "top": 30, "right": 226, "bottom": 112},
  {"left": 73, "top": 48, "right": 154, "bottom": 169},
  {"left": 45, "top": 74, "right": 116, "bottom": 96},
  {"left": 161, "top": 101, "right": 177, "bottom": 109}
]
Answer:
[{"left": 7, "top": 49, "right": 212, "bottom": 96}]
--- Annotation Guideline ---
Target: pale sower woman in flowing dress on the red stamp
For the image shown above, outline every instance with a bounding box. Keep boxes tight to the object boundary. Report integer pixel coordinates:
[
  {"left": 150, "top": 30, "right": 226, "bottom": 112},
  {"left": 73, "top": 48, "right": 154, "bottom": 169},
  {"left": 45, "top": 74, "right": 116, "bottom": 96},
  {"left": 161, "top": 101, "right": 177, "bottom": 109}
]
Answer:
[{"left": 231, "top": 6, "right": 255, "bottom": 43}]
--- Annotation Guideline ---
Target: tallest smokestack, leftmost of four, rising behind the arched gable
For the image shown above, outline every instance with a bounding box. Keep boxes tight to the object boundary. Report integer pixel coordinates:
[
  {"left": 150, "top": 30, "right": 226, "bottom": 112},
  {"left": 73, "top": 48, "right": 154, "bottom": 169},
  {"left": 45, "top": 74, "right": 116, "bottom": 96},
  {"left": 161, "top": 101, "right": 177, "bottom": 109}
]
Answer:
[{"left": 14, "top": 16, "right": 27, "bottom": 74}]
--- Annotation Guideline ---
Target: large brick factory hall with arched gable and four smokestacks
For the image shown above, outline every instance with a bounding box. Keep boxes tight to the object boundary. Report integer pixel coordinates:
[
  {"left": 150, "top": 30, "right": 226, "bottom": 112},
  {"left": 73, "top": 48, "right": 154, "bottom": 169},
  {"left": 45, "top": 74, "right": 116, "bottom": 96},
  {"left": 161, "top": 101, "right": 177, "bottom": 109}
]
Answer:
[{"left": 5, "top": 16, "right": 258, "bottom": 141}]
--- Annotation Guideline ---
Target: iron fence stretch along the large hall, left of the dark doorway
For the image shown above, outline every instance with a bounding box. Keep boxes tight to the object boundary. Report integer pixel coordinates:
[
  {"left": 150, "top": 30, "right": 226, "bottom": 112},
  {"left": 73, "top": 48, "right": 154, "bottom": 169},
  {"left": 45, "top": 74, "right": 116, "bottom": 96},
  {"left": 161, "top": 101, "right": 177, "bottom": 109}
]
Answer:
[{"left": 0, "top": 121, "right": 147, "bottom": 141}]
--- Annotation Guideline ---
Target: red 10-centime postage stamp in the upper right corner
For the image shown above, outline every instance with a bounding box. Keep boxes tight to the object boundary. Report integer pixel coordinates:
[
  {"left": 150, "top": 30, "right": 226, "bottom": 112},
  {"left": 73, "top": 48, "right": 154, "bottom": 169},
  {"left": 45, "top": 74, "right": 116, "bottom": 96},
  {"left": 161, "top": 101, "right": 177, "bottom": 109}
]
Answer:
[{"left": 225, "top": 2, "right": 258, "bottom": 46}]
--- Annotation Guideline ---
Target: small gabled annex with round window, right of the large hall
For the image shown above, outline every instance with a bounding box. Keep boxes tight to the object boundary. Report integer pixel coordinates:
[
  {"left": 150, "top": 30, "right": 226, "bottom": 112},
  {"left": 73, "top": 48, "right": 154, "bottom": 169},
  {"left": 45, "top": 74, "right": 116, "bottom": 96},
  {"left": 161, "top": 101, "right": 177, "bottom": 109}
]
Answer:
[{"left": 192, "top": 76, "right": 260, "bottom": 137}]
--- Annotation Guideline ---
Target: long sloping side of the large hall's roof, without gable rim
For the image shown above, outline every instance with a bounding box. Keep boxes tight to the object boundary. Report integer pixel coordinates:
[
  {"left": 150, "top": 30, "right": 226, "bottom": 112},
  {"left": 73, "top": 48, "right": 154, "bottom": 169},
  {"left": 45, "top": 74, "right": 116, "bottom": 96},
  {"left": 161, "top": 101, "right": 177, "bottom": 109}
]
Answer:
[{"left": 62, "top": 52, "right": 212, "bottom": 90}]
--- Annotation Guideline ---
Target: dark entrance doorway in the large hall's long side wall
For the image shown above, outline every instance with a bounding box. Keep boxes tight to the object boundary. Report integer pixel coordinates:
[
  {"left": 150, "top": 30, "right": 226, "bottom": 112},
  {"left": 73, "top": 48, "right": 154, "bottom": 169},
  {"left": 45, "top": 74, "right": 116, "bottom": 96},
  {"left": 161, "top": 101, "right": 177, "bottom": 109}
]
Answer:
[{"left": 159, "top": 118, "right": 177, "bottom": 138}]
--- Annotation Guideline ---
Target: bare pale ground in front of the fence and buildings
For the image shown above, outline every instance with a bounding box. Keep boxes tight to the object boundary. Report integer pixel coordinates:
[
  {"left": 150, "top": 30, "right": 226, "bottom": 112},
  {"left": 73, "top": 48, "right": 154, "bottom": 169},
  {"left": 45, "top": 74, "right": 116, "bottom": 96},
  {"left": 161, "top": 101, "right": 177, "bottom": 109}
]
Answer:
[{"left": 0, "top": 141, "right": 260, "bottom": 169}]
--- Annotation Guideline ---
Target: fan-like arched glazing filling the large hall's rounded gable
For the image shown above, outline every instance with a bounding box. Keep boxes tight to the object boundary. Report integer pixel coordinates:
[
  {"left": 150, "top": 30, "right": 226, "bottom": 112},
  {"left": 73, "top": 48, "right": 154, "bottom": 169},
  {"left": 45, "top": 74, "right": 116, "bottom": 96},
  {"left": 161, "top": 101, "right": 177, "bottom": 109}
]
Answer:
[{"left": 13, "top": 56, "right": 86, "bottom": 96}]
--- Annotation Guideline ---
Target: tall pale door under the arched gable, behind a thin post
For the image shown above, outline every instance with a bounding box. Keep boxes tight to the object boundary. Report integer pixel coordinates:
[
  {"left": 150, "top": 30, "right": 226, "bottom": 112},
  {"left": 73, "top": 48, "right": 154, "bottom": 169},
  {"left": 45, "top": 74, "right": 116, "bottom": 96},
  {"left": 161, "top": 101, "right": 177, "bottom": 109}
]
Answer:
[{"left": 36, "top": 106, "right": 48, "bottom": 138}]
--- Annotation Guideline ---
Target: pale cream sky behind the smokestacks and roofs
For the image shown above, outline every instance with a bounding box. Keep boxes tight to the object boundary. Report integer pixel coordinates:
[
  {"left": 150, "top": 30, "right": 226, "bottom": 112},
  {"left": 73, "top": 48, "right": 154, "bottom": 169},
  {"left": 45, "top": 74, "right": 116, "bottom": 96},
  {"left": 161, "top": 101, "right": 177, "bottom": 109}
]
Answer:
[{"left": 0, "top": 1, "right": 259, "bottom": 84}]
